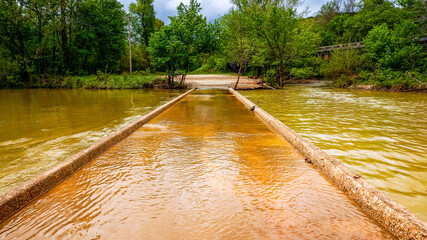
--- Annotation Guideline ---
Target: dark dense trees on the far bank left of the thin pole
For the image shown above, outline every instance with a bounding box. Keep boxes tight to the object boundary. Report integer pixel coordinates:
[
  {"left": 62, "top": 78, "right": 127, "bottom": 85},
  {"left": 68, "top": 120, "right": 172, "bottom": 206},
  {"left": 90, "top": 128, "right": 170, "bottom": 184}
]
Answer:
[{"left": 0, "top": 0, "right": 125, "bottom": 84}]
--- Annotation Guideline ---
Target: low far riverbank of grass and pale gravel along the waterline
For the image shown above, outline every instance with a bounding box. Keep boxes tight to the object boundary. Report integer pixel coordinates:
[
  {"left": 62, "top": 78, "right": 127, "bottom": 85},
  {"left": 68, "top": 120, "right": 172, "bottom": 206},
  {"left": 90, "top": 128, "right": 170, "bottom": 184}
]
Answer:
[{"left": 4, "top": 73, "right": 427, "bottom": 93}]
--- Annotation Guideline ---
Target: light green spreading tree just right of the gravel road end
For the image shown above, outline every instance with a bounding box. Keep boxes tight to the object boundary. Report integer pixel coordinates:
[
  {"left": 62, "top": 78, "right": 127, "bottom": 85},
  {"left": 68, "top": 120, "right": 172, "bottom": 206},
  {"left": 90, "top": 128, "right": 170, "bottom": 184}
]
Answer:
[{"left": 244, "top": 1, "right": 320, "bottom": 87}]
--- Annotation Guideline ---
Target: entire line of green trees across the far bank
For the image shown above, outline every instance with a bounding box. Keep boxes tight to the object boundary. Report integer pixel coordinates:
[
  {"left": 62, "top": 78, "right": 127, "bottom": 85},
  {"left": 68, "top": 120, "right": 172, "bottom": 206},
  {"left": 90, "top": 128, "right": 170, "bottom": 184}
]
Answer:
[{"left": 0, "top": 0, "right": 427, "bottom": 88}]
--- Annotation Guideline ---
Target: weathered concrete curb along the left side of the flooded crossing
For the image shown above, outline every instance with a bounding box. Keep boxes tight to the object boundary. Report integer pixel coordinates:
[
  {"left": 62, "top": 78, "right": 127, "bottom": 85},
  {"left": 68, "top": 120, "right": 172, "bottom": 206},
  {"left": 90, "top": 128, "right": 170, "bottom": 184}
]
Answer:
[{"left": 0, "top": 88, "right": 196, "bottom": 223}]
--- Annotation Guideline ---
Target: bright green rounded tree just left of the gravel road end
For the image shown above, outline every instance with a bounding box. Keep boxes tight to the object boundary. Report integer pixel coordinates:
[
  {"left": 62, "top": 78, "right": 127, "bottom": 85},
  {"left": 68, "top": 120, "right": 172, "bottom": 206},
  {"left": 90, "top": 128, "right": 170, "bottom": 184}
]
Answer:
[{"left": 148, "top": 0, "right": 219, "bottom": 76}]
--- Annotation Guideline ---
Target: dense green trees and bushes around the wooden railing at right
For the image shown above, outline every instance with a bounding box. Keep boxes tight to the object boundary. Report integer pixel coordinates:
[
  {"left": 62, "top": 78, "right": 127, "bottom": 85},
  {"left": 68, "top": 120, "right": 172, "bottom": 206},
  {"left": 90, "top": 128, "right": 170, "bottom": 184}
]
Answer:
[{"left": 315, "top": 0, "right": 427, "bottom": 88}]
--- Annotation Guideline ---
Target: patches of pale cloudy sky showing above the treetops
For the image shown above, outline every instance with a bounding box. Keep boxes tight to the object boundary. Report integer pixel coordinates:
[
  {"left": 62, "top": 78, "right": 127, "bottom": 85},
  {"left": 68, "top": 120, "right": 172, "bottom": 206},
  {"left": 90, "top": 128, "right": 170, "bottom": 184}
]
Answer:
[{"left": 119, "top": 0, "right": 327, "bottom": 24}]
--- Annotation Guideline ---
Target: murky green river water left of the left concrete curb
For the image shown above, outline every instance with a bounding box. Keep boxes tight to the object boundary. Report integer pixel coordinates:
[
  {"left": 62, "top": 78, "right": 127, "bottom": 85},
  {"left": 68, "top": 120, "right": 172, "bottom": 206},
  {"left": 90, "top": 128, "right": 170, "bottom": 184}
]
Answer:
[{"left": 0, "top": 89, "right": 182, "bottom": 194}]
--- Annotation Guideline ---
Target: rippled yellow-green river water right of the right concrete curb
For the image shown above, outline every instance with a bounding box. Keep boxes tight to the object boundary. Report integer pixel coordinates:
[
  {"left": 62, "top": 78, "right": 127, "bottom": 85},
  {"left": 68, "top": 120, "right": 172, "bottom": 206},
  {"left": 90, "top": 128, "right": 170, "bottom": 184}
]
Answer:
[{"left": 242, "top": 85, "right": 427, "bottom": 220}]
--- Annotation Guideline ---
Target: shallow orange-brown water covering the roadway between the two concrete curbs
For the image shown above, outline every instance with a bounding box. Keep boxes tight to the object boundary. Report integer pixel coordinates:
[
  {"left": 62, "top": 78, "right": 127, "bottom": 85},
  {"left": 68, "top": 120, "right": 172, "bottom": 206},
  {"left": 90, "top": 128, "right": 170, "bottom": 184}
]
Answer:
[{"left": 0, "top": 90, "right": 392, "bottom": 239}]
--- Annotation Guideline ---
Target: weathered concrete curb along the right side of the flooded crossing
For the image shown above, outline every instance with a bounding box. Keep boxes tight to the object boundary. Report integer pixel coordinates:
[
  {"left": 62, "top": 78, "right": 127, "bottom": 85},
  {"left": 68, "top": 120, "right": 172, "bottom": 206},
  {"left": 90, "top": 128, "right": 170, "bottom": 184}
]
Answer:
[{"left": 229, "top": 88, "right": 427, "bottom": 239}]
